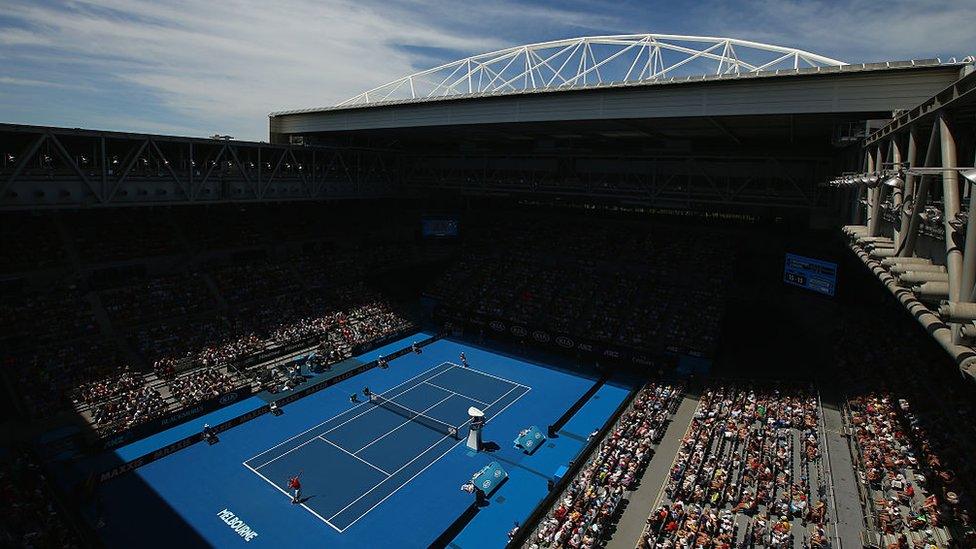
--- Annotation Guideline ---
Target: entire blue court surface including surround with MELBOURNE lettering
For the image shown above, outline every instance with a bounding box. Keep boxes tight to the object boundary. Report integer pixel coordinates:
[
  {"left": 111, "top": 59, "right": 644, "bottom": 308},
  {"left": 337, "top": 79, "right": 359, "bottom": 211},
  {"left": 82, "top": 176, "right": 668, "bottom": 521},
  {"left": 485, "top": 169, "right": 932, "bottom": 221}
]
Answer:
[{"left": 89, "top": 336, "right": 629, "bottom": 549}]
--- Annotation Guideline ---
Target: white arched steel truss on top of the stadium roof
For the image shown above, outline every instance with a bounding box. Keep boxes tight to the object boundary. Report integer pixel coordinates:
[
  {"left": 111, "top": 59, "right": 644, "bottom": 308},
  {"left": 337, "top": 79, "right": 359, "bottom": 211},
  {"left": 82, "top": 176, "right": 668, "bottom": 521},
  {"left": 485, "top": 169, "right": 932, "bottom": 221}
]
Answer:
[{"left": 272, "top": 34, "right": 847, "bottom": 116}]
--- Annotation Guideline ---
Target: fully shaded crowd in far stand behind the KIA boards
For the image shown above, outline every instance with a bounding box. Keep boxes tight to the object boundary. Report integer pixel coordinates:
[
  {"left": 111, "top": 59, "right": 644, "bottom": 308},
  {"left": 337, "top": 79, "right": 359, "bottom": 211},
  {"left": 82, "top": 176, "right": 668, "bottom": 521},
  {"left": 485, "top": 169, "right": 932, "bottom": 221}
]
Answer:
[{"left": 427, "top": 215, "right": 731, "bottom": 355}]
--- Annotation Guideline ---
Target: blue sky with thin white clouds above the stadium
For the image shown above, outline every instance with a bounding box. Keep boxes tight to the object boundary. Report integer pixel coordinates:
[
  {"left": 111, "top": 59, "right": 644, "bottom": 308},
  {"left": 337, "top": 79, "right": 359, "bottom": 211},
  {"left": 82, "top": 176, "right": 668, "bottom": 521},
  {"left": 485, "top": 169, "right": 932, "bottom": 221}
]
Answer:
[{"left": 0, "top": 0, "right": 976, "bottom": 140}]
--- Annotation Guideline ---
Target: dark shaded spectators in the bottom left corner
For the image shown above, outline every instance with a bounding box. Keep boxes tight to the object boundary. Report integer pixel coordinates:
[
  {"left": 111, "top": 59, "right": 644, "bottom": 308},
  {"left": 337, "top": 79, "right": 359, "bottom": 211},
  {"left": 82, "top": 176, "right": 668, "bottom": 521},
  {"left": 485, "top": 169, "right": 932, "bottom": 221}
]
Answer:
[{"left": 0, "top": 449, "right": 85, "bottom": 549}]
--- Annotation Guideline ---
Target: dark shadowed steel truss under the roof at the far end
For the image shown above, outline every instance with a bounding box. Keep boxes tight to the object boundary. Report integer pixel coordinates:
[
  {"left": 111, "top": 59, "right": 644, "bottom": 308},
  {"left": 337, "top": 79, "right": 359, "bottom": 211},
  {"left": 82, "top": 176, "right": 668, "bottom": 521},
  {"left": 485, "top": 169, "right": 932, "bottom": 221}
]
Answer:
[{"left": 401, "top": 155, "right": 831, "bottom": 208}]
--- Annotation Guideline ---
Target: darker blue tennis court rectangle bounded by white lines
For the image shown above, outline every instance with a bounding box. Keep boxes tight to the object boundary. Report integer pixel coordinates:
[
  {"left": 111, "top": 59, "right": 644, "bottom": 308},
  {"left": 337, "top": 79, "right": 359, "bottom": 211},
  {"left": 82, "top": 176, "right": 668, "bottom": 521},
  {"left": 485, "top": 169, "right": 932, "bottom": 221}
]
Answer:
[{"left": 244, "top": 362, "right": 530, "bottom": 532}]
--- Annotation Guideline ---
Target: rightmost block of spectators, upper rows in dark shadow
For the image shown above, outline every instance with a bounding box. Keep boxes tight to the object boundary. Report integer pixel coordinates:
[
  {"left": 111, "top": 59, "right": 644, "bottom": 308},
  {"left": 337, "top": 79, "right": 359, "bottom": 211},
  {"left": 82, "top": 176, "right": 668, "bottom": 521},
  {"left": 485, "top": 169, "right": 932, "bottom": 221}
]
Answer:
[{"left": 835, "top": 309, "right": 976, "bottom": 549}]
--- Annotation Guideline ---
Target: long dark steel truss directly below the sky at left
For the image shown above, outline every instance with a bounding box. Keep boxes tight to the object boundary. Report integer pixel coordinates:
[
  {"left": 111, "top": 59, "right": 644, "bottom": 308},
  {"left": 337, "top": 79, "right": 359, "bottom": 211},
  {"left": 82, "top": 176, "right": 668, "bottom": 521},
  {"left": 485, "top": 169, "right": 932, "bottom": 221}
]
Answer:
[{"left": 0, "top": 125, "right": 398, "bottom": 209}]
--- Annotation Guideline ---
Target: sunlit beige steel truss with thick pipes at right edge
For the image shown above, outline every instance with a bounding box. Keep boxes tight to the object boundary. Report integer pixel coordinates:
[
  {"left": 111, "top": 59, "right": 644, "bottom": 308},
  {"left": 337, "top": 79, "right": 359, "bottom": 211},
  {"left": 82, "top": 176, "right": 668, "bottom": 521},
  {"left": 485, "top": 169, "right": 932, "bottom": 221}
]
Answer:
[{"left": 842, "top": 65, "right": 976, "bottom": 379}]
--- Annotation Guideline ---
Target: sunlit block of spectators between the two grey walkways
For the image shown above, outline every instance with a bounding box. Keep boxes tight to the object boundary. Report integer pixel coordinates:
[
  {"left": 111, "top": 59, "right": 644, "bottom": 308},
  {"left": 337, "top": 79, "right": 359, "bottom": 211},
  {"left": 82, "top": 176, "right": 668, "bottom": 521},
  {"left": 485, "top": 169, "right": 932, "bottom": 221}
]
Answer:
[{"left": 639, "top": 383, "right": 830, "bottom": 549}]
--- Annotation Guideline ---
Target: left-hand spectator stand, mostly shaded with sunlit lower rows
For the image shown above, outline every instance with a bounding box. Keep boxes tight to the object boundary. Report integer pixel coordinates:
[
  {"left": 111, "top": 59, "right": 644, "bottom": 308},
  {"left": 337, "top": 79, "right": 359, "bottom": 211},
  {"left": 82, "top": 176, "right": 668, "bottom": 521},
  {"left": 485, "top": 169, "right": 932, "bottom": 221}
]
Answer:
[{"left": 0, "top": 206, "right": 423, "bottom": 434}]
